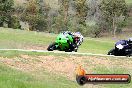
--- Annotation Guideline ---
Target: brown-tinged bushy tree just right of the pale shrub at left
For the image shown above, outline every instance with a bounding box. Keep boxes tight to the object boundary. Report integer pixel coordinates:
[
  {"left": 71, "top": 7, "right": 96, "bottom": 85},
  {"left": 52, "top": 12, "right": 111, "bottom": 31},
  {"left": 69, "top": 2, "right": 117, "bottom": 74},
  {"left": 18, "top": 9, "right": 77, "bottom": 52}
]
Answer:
[{"left": 21, "top": 0, "right": 50, "bottom": 31}]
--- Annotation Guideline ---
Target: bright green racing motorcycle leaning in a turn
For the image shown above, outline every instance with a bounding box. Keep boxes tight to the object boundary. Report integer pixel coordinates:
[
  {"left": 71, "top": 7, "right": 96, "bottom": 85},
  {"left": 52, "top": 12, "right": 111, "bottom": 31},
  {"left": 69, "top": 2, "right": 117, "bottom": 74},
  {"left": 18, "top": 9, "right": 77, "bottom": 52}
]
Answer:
[{"left": 47, "top": 33, "right": 77, "bottom": 52}]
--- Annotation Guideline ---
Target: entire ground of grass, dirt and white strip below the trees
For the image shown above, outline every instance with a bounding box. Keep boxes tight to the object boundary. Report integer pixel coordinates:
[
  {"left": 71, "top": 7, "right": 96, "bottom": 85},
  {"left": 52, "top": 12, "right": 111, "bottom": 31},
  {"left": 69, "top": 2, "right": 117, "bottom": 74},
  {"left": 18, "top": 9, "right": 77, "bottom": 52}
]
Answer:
[{"left": 0, "top": 28, "right": 132, "bottom": 88}]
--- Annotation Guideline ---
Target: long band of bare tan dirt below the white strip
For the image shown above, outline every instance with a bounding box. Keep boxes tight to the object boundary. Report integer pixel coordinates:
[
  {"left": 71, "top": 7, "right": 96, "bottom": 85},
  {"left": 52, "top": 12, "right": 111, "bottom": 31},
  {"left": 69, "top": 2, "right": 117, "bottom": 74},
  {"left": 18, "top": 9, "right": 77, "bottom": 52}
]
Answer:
[{"left": 0, "top": 55, "right": 132, "bottom": 80}]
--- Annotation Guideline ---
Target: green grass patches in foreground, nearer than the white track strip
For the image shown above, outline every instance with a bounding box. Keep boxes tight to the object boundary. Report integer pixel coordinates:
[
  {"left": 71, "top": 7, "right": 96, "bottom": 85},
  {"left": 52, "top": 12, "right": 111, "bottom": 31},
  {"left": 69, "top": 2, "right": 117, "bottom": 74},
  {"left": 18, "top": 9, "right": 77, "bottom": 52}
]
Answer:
[{"left": 0, "top": 51, "right": 132, "bottom": 88}]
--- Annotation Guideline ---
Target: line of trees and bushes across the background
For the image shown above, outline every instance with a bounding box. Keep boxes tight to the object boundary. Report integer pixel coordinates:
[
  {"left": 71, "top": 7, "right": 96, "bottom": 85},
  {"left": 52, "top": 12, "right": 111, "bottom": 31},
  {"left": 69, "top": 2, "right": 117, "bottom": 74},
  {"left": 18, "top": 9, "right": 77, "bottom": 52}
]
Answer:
[{"left": 0, "top": 0, "right": 128, "bottom": 37}]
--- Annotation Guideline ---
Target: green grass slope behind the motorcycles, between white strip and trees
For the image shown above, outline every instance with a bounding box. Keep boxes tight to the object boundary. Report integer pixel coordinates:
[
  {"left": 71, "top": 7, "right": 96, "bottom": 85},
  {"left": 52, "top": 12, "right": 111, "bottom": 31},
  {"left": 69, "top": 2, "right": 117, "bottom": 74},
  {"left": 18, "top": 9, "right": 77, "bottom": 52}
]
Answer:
[{"left": 0, "top": 28, "right": 114, "bottom": 54}]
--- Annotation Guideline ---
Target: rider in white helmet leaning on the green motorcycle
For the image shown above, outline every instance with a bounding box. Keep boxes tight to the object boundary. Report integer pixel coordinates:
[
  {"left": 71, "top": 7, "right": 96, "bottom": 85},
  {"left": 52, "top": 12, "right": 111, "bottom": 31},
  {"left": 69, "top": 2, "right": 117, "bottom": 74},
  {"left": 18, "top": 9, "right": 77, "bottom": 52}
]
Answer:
[{"left": 62, "top": 31, "right": 83, "bottom": 50}]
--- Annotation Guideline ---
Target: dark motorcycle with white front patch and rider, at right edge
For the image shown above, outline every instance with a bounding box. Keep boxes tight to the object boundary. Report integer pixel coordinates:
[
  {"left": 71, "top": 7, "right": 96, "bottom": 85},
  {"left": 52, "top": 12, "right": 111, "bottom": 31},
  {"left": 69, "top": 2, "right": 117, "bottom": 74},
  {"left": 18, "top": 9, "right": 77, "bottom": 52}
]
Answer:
[{"left": 108, "top": 40, "right": 132, "bottom": 56}]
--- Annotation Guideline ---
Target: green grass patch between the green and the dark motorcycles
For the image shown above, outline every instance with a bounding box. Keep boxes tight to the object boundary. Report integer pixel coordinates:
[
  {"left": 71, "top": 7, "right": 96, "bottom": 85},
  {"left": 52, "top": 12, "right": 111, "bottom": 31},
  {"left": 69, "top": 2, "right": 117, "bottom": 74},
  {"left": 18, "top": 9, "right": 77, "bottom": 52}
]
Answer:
[{"left": 79, "top": 39, "right": 114, "bottom": 54}]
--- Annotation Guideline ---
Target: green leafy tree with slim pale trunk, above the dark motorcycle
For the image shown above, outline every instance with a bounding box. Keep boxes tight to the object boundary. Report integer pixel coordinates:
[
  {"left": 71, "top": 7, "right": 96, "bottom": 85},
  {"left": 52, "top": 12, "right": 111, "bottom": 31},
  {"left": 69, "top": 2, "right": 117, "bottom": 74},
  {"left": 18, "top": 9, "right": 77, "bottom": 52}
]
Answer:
[{"left": 100, "top": 0, "right": 127, "bottom": 36}]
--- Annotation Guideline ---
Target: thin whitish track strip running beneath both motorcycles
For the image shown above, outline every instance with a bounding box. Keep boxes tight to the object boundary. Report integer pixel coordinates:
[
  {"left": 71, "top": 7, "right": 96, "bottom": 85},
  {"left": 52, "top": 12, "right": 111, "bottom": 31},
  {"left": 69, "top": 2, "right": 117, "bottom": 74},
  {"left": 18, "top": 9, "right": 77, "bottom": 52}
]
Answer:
[{"left": 0, "top": 49, "right": 132, "bottom": 58}]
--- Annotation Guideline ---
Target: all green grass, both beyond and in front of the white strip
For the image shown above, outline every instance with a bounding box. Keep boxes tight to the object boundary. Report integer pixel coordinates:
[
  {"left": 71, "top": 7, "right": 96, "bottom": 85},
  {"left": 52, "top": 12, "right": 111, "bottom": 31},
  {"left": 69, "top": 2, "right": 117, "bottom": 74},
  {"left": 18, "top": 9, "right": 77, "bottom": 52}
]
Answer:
[{"left": 0, "top": 28, "right": 132, "bottom": 88}]
